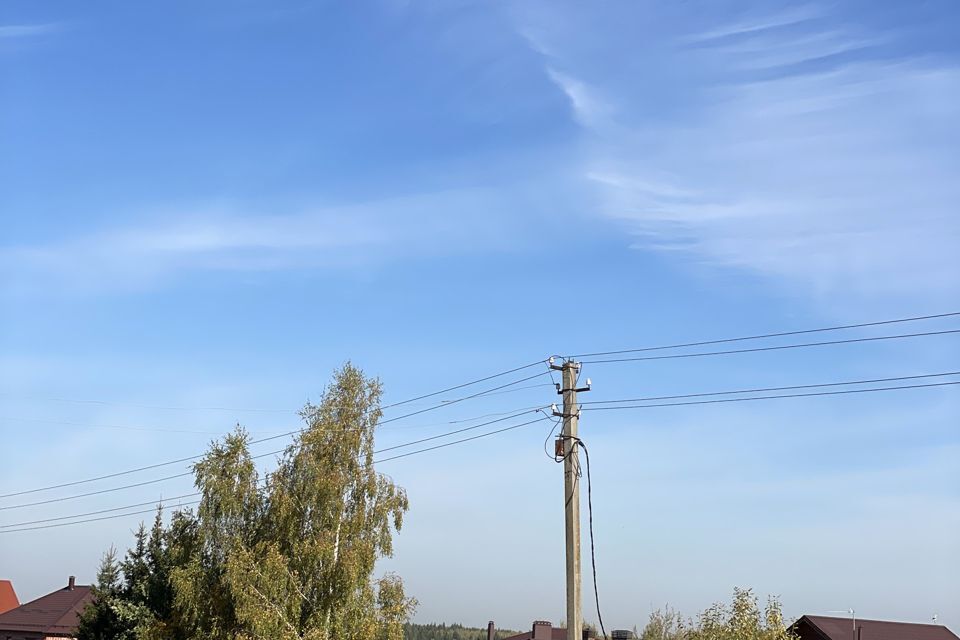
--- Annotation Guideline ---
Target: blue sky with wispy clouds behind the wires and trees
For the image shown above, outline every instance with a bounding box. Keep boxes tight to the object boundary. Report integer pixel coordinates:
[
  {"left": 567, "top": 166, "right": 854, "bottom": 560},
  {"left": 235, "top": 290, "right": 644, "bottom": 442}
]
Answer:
[{"left": 0, "top": 0, "right": 960, "bottom": 629}]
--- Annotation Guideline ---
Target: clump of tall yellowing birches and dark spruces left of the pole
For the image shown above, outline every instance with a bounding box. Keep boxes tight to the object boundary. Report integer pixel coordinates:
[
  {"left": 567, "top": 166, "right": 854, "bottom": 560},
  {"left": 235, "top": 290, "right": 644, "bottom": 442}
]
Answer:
[{"left": 78, "top": 364, "right": 416, "bottom": 640}]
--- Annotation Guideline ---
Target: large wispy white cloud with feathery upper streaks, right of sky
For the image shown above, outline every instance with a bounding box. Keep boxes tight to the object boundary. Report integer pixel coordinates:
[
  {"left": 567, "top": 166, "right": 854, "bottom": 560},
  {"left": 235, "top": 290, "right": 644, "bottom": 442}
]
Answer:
[{"left": 516, "top": 2, "right": 960, "bottom": 299}]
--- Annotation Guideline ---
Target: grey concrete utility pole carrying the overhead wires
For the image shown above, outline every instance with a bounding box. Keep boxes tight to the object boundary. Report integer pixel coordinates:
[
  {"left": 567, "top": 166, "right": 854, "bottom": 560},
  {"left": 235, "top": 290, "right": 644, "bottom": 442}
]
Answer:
[{"left": 550, "top": 360, "right": 590, "bottom": 640}]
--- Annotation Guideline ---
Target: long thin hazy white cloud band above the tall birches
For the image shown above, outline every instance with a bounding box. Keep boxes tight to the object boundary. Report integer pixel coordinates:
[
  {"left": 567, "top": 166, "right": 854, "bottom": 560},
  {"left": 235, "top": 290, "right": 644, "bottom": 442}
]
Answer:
[{"left": 0, "top": 190, "right": 532, "bottom": 293}]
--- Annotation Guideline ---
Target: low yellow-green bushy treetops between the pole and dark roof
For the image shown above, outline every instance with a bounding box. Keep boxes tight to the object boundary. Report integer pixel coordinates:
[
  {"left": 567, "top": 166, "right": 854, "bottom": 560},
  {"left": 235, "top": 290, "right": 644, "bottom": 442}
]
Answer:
[{"left": 640, "top": 589, "right": 796, "bottom": 640}]
